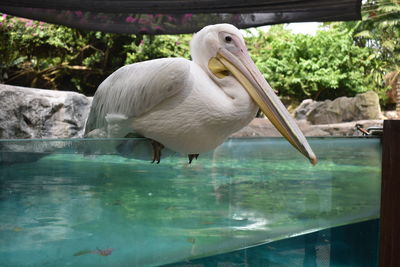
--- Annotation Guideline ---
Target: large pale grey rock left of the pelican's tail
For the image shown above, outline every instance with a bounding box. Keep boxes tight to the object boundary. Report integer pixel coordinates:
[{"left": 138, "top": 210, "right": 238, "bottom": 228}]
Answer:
[{"left": 0, "top": 84, "right": 91, "bottom": 139}]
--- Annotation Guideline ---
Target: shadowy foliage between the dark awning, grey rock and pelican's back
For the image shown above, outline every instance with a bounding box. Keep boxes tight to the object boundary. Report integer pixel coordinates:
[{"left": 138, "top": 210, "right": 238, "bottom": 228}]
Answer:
[{"left": 0, "top": 14, "right": 190, "bottom": 95}]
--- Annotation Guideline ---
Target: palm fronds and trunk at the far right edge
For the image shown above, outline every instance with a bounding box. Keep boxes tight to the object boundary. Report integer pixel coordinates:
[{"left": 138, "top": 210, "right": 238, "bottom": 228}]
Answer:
[{"left": 331, "top": 0, "right": 400, "bottom": 108}]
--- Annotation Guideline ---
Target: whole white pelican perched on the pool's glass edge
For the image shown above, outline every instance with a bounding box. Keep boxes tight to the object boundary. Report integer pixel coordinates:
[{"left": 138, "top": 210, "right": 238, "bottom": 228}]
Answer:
[{"left": 85, "top": 24, "right": 317, "bottom": 164}]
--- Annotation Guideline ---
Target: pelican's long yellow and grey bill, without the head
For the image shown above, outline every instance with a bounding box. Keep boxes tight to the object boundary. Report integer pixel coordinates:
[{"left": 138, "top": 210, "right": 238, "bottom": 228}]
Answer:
[{"left": 208, "top": 47, "right": 317, "bottom": 165}]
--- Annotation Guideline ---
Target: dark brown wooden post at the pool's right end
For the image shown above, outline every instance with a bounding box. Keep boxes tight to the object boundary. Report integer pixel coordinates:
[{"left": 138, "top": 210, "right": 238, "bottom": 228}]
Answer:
[{"left": 379, "top": 120, "right": 400, "bottom": 267}]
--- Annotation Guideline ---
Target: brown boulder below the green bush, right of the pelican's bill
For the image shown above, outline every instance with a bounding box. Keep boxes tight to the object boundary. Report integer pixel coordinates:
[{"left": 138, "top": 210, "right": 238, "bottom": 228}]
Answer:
[{"left": 295, "top": 91, "right": 381, "bottom": 124}]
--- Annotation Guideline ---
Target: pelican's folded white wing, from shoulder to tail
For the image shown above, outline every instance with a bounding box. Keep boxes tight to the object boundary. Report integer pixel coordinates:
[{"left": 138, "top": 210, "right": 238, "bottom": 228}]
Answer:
[{"left": 85, "top": 58, "right": 190, "bottom": 135}]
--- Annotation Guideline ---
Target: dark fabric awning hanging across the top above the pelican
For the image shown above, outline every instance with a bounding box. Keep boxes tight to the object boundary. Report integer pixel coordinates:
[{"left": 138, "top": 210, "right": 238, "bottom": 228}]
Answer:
[{"left": 0, "top": 0, "right": 361, "bottom": 34}]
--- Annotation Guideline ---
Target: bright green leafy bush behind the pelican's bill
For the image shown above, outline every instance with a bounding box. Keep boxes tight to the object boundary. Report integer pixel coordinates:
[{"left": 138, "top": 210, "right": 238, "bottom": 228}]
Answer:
[{"left": 248, "top": 25, "right": 374, "bottom": 100}]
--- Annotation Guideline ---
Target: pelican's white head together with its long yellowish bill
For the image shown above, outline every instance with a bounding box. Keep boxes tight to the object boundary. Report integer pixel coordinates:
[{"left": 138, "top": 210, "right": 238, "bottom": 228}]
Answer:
[{"left": 190, "top": 24, "right": 317, "bottom": 164}]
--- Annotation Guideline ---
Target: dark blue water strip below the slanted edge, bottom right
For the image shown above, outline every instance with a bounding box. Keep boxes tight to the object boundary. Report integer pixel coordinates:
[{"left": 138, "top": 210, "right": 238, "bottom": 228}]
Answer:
[{"left": 164, "top": 220, "right": 379, "bottom": 267}]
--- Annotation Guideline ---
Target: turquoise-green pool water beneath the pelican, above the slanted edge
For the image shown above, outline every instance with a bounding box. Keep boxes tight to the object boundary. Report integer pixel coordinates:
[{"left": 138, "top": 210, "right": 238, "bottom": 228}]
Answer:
[{"left": 0, "top": 138, "right": 381, "bottom": 266}]
